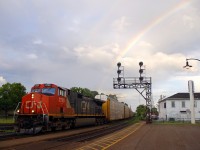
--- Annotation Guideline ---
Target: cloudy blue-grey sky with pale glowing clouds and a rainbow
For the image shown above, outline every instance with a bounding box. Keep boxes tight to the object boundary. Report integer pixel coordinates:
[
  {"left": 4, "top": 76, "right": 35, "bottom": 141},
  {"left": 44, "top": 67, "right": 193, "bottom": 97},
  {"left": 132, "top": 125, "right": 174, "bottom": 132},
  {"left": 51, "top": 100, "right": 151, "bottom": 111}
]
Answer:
[{"left": 0, "top": 0, "right": 200, "bottom": 110}]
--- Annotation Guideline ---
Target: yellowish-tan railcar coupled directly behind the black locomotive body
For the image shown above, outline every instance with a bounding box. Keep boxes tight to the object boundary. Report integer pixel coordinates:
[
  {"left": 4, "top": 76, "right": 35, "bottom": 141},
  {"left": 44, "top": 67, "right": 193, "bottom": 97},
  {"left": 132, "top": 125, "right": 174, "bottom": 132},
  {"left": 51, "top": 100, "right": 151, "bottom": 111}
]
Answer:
[{"left": 102, "top": 97, "right": 124, "bottom": 121}]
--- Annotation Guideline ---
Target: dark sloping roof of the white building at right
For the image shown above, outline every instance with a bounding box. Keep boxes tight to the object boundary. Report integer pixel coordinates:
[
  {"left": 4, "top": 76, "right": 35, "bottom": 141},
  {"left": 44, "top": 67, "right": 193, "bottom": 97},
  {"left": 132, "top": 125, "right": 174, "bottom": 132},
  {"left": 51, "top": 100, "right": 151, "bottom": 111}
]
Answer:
[{"left": 159, "top": 93, "right": 200, "bottom": 102}]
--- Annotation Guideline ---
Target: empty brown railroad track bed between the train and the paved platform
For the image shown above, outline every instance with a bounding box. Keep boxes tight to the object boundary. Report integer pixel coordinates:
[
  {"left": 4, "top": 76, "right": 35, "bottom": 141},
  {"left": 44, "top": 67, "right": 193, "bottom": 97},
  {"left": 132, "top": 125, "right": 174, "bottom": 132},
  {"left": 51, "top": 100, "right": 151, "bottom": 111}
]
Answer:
[{"left": 0, "top": 121, "right": 134, "bottom": 150}]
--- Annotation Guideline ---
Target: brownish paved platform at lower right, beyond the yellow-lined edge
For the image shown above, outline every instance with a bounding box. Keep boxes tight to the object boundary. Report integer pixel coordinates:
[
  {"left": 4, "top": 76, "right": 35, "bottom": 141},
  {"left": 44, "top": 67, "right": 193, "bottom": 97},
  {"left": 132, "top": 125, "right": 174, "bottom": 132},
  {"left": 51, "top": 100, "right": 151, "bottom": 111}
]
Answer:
[{"left": 108, "top": 124, "right": 200, "bottom": 150}]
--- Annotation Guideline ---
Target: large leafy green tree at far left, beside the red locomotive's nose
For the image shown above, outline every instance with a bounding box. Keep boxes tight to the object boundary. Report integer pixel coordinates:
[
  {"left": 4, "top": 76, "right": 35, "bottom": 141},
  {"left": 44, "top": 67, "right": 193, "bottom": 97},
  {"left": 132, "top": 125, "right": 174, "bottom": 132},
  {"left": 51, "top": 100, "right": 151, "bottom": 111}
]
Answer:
[{"left": 0, "top": 83, "right": 26, "bottom": 116}]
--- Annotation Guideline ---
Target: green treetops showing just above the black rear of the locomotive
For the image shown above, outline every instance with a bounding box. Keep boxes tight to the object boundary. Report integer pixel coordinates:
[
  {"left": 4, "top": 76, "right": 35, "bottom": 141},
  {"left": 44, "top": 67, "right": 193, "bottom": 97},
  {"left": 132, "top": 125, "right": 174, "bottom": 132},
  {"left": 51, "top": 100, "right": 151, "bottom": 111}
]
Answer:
[{"left": 70, "top": 87, "right": 98, "bottom": 98}]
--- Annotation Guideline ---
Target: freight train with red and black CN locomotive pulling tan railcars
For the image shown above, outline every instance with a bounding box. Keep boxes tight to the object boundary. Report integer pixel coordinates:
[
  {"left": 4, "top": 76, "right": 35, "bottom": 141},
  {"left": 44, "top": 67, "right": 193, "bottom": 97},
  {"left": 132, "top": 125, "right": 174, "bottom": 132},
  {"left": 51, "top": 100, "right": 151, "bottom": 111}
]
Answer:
[{"left": 14, "top": 84, "right": 133, "bottom": 133}]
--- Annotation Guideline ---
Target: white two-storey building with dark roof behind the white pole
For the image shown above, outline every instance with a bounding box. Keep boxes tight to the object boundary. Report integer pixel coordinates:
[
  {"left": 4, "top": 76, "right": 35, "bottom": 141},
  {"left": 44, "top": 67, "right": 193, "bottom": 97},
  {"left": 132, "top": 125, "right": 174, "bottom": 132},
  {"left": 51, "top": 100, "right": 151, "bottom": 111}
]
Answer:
[{"left": 158, "top": 93, "right": 200, "bottom": 121}]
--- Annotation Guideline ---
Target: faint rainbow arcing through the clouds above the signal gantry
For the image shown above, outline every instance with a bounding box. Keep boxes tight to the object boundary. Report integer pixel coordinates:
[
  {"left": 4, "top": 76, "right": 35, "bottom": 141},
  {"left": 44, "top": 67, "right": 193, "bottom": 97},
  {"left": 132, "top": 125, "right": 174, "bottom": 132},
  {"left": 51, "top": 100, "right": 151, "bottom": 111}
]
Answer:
[{"left": 116, "top": 0, "right": 191, "bottom": 62}]
